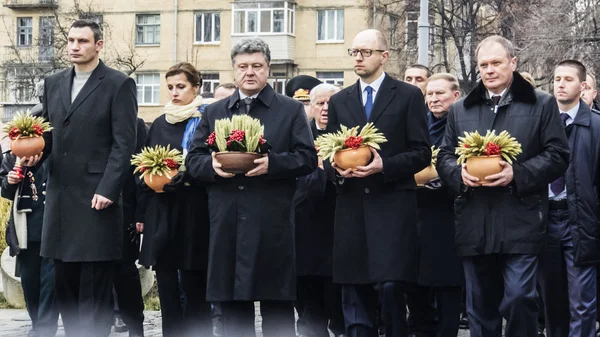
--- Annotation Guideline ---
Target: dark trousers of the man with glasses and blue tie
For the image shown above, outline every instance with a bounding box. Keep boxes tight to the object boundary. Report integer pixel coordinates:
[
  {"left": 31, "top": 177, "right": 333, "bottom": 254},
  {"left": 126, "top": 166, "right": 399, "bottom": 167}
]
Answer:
[{"left": 342, "top": 282, "right": 408, "bottom": 337}]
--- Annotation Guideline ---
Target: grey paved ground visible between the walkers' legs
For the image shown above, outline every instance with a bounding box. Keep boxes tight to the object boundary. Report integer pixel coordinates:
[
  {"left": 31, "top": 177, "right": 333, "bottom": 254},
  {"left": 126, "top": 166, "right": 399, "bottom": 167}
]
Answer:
[{"left": 0, "top": 309, "right": 469, "bottom": 337}]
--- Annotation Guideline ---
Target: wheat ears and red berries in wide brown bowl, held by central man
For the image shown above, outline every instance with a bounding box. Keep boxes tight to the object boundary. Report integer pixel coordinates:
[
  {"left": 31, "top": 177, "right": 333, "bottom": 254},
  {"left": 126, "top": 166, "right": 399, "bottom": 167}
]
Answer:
[{"left": 206, "top": 115, "right": 271, "bottom": 154}]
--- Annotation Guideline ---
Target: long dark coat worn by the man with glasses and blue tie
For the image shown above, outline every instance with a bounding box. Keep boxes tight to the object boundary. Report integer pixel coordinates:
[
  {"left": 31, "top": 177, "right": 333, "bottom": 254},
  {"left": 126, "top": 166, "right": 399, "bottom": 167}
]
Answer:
[{"left": 324, "top": 75, "right": 431, "bottom": 284}]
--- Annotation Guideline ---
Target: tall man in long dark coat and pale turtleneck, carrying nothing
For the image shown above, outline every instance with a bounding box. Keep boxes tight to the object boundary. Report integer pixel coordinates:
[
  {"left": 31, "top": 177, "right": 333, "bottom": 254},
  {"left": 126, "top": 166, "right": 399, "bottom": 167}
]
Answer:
[{"left": 41, "top": 20, "right": 137, "bottom": 337}]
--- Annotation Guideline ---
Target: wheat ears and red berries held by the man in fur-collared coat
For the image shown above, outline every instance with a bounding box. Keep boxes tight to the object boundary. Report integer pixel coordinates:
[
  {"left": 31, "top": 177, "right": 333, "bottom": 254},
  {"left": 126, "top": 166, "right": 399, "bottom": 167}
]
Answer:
[{"left": 455, "top": 130, "right": 522, "bottom": 164}]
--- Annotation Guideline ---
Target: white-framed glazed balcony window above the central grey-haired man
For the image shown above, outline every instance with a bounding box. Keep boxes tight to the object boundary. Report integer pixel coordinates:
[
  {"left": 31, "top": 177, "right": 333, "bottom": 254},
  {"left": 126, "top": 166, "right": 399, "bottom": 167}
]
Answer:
[{"left": 231, "top": 0, "right": 296, "bottom": 36}]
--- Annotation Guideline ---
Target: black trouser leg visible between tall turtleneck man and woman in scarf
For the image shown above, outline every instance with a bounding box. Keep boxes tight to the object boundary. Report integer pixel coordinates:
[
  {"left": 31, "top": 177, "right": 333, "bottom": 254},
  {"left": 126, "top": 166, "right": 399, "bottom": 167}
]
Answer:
[{"left": 113, "top": 261, "right": 144, "bottom": 335}]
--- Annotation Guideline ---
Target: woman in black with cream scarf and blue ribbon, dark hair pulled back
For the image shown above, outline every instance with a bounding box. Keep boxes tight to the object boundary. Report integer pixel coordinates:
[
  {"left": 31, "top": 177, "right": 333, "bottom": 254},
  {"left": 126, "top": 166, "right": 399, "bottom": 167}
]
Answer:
[{"left": 137, "top": 62, "right": 212, "bottom": 337}]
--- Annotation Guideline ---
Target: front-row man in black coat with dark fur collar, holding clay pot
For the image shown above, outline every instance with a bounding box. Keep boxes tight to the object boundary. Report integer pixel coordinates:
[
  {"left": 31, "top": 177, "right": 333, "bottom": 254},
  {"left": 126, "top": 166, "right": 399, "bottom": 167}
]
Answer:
[{"left": 437, "top": 36, "right": 569, "bottom": 337}]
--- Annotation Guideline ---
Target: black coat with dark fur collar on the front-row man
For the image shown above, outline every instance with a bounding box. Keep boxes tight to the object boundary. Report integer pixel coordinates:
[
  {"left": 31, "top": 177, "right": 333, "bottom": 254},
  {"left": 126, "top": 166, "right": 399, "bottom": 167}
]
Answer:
[{"left": 437, "top": 72, "right": 569, "bottom": 256}]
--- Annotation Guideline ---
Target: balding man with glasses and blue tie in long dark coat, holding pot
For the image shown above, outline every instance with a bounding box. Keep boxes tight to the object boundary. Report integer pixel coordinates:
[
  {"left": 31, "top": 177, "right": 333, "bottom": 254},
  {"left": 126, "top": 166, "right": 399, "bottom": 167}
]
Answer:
[{"left": 325, "top": 30, "right": 431, "bottom": 337}]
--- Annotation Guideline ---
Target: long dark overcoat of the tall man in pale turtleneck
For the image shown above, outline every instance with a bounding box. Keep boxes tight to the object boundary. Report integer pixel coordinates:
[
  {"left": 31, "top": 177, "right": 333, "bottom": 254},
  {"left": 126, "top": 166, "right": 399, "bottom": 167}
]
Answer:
[{"left": 41, "top": 62, "right": 137, "bottom": 262}]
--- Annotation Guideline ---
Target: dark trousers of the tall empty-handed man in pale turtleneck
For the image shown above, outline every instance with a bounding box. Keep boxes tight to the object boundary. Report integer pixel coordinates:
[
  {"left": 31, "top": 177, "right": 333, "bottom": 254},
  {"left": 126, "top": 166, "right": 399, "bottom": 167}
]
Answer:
[{"left": 54, "top": 260, "right": 115, "bottom": 337}]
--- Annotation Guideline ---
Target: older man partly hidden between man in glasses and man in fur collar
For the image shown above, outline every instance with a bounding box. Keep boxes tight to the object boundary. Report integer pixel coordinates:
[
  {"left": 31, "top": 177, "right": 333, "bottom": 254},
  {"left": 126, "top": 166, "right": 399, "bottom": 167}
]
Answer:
[{"left": 417, "top": 73, "right": 464, "bottom": 337}]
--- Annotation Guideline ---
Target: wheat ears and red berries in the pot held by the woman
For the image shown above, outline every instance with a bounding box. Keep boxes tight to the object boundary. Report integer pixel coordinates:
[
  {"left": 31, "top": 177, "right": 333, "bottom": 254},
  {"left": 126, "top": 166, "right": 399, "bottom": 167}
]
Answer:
[{"left": 131, "top": 145, "right": 183, "bottom": 179}]
